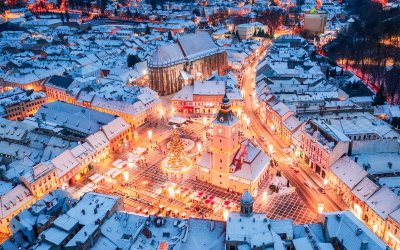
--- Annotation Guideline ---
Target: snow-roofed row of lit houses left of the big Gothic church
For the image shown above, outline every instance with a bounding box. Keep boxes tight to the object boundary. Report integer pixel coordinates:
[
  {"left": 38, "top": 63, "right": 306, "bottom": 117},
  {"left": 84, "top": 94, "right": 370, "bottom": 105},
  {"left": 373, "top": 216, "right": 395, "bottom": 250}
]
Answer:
[{"left": 44, "top": 75, "right": 162, "bottom": 127}]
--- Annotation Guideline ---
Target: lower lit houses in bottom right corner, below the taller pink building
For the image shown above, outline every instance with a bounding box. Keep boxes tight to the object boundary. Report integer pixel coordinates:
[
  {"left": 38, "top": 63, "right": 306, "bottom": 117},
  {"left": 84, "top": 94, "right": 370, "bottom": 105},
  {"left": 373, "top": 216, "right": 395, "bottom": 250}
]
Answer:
[{"left": 327, "top": 156, "right": 400, "bottom": 249}]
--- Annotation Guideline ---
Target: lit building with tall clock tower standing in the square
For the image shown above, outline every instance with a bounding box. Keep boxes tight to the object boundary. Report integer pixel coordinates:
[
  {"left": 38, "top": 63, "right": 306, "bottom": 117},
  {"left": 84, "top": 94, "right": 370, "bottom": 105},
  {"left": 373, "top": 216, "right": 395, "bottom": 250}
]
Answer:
[{"left": 197, "top": 95, "right": 270, "bottom": 195}]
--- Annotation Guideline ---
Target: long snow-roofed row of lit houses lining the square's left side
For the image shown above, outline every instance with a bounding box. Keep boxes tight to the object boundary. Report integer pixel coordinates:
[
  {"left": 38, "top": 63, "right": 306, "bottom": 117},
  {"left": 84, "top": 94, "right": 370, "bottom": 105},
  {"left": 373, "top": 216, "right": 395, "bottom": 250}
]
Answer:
[{"left": 0, "top": 102, "right": 132, "bottom": 233}]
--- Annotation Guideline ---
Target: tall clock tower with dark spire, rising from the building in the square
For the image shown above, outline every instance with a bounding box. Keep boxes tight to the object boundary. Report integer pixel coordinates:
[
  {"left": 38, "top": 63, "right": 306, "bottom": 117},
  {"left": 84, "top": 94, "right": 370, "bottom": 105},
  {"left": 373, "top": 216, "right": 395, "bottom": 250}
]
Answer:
[{"left": 211, "top": 94, "right": 240, "bottom": 188}]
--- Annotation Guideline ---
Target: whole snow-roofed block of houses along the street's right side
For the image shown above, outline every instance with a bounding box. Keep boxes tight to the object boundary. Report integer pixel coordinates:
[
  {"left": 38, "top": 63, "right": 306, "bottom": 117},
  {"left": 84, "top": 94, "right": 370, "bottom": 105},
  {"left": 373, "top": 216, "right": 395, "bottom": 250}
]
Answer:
[{"left": 256, "top": 36, "right": 400, "bottom": 249}]
